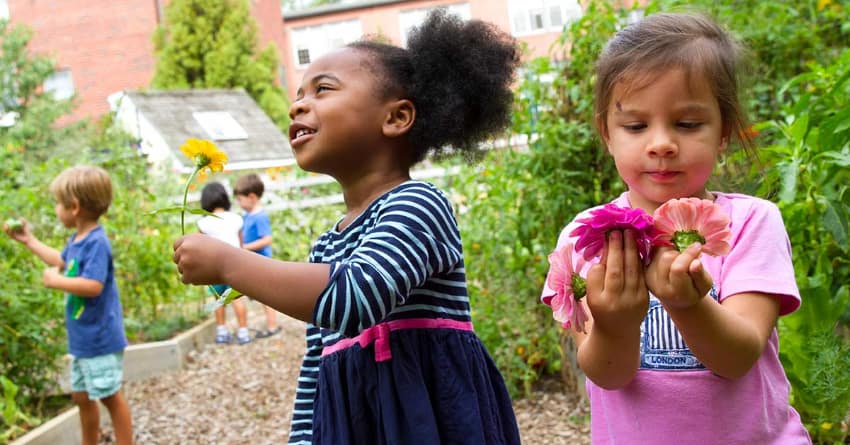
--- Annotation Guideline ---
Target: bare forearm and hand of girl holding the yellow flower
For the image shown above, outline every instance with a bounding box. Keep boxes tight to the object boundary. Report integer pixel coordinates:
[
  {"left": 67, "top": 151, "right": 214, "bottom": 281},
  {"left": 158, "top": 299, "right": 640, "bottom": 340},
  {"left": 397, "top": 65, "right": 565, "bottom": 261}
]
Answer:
[{"left": 174, "top": 234, "right": 330, "bottom": 323}]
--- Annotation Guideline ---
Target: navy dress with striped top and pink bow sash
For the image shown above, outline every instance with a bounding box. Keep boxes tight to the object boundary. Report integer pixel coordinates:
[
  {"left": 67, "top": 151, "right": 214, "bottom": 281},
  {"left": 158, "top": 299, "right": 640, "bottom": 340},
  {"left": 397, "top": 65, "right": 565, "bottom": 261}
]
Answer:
[{"left": 289, "top": 181, "right": 520, "bottom": 445}]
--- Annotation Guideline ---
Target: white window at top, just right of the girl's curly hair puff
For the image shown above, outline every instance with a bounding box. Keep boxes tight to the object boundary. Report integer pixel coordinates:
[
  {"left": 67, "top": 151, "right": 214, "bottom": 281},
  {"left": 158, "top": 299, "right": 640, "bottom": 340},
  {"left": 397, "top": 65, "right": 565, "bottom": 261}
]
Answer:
[{"left": 508, "top": 0, "right": 582, "bottom": 36}]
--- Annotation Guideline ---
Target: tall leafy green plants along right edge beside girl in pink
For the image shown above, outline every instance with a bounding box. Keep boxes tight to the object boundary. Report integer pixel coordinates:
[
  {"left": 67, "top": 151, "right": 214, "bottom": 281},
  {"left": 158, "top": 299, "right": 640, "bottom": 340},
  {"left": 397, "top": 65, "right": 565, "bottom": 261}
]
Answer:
[{"left": 753, "top": 49, "right": 850, "bottom": 443}]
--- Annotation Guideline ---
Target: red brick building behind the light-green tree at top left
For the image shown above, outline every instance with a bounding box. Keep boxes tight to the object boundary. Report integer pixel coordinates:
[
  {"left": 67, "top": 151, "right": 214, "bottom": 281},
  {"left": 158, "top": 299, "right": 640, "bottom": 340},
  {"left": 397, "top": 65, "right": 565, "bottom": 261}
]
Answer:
[{"left": 0, "top": 0, "right": 284, "bottom": 119}]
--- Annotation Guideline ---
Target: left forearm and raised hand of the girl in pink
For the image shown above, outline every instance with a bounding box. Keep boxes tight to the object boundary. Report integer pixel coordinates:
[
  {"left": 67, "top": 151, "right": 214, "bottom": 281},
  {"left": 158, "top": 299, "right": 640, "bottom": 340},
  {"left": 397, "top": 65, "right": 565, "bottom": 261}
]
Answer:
[{"left": 573, "top": 230, "right": 649, "bottom": 389}]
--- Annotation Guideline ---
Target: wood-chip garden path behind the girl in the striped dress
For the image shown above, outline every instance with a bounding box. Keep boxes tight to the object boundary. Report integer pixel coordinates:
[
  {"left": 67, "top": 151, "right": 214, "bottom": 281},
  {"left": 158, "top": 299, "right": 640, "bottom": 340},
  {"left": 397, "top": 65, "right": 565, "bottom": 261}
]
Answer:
[{"left": 100, "top": 302, "right": 590, "bottom": 445}]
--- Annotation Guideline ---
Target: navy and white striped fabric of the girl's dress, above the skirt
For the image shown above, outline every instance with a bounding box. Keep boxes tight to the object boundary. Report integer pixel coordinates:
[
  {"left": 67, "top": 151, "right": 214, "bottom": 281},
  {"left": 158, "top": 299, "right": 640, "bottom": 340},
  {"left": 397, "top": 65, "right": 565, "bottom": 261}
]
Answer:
[{"left": 289, "top": 181, "right": 471, "bottom": 444}]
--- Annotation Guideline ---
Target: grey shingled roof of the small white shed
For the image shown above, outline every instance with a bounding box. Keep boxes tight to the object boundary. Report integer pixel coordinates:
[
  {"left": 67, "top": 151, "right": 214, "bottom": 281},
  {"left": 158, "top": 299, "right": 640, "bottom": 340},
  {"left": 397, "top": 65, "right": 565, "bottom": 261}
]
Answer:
[{"left": 126, "top": 89, "right": 294, "bottom": 170}]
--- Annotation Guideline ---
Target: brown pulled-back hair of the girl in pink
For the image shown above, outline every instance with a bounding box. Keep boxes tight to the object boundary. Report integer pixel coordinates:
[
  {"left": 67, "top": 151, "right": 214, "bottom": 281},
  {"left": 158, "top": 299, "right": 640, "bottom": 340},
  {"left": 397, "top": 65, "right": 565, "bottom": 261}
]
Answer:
[{"left": 594, "top": 13, "right": 753, "bottom": 154}]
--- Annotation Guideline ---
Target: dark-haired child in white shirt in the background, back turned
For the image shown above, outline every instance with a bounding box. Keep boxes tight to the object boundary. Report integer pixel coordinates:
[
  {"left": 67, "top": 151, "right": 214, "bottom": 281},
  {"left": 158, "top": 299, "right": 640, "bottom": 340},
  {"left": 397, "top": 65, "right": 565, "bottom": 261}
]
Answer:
[{"left": 198, "top": 182, "right": 251, "bottom": 345}]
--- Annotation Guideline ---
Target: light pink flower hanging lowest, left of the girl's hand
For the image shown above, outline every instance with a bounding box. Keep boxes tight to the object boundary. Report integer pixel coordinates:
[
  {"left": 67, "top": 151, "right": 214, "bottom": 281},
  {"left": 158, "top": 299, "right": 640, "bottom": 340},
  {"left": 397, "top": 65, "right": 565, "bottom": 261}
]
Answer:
[{"left": 543, "top": 243, "right": 587, "bottom": 332}]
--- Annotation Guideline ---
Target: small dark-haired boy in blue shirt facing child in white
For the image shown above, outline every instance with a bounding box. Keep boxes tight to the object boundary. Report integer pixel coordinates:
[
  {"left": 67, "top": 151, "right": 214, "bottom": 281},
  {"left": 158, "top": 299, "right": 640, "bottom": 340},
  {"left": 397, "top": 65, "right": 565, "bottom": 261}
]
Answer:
[{"left": 233, "top": 173, "right": 280, "bottom": 338}]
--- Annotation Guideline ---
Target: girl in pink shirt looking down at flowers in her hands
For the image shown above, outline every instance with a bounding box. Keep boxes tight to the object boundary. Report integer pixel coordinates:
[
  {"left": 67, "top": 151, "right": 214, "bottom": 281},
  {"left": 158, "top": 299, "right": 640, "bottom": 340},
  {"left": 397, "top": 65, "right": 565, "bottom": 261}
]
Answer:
[{"left": 543, "top": 14, "right": 811, "bottom": 445}]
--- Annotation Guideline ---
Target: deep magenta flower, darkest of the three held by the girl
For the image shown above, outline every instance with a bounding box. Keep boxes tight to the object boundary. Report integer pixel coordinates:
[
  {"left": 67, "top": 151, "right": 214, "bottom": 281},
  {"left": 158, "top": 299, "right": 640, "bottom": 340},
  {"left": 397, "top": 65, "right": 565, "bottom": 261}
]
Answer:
[{"left": 570, "top": 204, "right": 658, "bottom": 261}]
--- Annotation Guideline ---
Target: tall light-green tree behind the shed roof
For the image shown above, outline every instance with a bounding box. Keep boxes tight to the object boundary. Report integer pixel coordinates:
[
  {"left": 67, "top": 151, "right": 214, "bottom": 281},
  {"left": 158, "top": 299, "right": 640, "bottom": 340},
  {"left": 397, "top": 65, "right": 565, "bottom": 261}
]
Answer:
[{"left": 152, "top": 0, "right": 289, "bottom": 128}]
